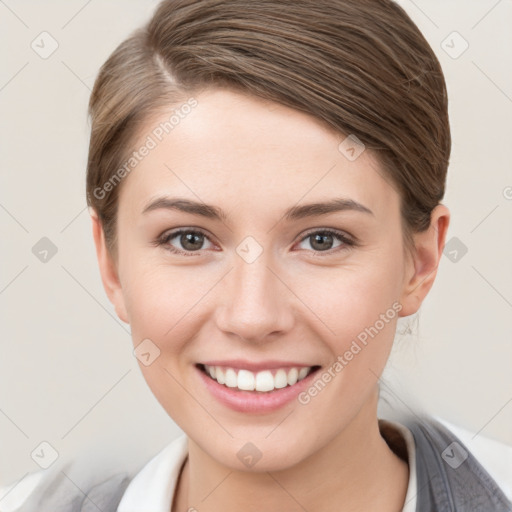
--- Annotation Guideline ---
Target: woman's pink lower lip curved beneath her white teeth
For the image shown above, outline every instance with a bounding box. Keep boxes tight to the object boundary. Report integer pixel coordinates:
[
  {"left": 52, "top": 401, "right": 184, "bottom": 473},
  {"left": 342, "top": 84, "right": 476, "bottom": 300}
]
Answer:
[{"left": 195, "top": 366, "right": 318, "bottom": 414}]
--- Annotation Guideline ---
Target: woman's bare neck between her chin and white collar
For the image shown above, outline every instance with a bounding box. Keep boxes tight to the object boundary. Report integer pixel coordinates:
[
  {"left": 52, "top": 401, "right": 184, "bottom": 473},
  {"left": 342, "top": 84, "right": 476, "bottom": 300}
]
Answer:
[{"left": 172, "top": 388, "right": 409, "bottom": 512}]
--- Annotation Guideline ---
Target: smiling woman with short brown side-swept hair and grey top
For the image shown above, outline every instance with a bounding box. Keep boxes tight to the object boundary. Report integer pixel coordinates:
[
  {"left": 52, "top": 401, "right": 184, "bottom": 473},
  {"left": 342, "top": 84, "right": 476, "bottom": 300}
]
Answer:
[{"left": 8, "top": 0, "right": 512, "bottom": 512}]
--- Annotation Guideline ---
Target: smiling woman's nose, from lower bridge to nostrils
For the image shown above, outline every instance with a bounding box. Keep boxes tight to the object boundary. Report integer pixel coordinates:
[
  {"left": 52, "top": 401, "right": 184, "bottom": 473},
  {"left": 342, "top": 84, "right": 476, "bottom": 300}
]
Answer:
[{"left": 216, "top": 252, "right": 294, "bottom": 343}]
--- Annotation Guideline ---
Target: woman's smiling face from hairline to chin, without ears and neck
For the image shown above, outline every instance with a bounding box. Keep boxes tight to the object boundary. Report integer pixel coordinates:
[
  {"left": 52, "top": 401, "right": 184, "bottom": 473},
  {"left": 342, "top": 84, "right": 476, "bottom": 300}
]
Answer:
[{"left": 95, "top": 90, "right": 440, "bottom": 471}]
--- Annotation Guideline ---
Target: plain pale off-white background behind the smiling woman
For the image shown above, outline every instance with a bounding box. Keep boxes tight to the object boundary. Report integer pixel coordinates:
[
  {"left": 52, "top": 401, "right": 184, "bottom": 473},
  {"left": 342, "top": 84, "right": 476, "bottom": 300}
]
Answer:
[{"left": 0, "top": 0, "right": 512, "bottom": 485}]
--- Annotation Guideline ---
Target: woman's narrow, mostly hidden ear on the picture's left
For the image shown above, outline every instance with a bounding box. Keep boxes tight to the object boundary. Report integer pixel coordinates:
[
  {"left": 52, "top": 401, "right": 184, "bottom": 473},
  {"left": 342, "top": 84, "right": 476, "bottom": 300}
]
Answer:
[{"left": 89, "top": 208, "right": 130, "bottom": 324}]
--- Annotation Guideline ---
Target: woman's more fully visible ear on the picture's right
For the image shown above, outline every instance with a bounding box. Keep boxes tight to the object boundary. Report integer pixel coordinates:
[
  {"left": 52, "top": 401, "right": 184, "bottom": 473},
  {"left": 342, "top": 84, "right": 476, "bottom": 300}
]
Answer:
[{"left": 400, "top": 204, "right": 450, "bottom": 316}]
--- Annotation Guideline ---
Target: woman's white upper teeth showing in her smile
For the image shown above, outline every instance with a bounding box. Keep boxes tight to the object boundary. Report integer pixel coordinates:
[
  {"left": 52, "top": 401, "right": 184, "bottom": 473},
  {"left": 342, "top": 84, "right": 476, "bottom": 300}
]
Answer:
[{"left": 204, "top": 364, "right": 312, "bottom": 391}]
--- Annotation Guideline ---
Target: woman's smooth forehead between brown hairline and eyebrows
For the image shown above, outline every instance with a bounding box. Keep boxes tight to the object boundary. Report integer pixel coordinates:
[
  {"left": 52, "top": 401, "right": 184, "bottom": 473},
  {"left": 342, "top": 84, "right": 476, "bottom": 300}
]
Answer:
[{"left": 120, "top": 89, "right": 398, "bottom": 220}]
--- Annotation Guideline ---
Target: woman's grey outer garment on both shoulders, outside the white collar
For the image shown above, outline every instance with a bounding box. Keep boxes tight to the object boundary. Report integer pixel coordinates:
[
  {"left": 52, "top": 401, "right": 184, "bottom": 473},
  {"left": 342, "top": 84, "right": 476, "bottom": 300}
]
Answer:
[{"left": 18, "top": 417, "right": 512, "bottom": 512}]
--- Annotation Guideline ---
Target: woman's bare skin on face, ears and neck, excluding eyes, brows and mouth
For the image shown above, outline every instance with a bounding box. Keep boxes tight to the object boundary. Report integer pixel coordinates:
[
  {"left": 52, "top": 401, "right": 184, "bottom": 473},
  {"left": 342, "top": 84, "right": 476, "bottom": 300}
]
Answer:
[{"left": 91, "top": 89, "right": 450, "bottom": 512}]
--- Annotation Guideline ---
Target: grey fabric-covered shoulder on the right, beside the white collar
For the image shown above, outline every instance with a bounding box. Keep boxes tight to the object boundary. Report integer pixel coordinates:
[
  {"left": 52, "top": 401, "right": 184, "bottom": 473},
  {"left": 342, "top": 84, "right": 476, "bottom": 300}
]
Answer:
[{"left": 403, "top": 416, "right": 512, "bottom": 512}]
